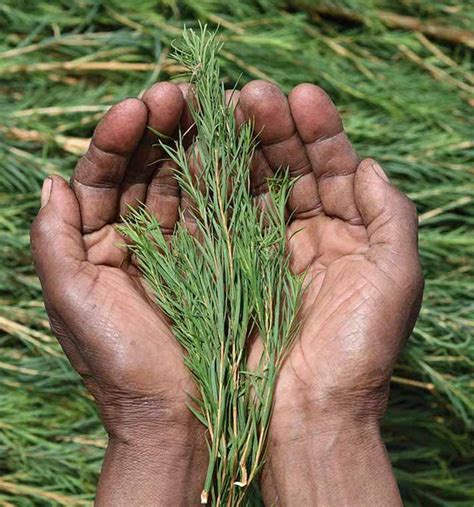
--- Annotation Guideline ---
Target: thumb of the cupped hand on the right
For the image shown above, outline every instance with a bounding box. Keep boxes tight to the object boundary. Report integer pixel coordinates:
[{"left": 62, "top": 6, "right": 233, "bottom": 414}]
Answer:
[{"left": 354, "top": 159, "right": 422, "bottom": 286}]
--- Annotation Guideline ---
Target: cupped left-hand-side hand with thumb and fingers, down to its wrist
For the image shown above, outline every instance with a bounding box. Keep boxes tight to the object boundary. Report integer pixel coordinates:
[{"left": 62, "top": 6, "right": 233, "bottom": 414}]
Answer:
[{"left": 31, "top": 83, "right": 206, "bottom": 505}]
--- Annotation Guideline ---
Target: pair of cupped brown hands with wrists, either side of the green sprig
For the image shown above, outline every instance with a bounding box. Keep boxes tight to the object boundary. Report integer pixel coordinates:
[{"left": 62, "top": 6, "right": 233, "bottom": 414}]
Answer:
[{"left": 31, "top": 81, "right": 423, "bottom": 506}]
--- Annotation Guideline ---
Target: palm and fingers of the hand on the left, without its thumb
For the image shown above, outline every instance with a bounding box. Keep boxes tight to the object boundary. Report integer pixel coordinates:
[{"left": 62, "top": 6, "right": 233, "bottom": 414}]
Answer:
[{"left": 73, "top": 83, "right": 194, "bottom": 406}]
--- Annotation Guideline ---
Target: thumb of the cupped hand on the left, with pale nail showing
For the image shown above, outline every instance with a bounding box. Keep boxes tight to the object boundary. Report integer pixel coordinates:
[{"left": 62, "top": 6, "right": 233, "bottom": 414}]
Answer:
[{"left": 30, "top": 176, "right": 86, "bottom": 298}]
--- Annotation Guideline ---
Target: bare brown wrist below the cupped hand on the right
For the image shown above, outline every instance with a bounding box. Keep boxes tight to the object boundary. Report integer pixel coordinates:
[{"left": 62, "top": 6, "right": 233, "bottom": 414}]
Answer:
[{"left": 262, "top": 413, "right": 401, "bottom": 506}]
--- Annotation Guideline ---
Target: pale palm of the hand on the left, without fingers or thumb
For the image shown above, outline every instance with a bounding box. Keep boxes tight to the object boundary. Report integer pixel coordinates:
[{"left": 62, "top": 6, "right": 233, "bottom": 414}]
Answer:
[{"left": 74, "top": 245, "right": 188, "bottom": 401}]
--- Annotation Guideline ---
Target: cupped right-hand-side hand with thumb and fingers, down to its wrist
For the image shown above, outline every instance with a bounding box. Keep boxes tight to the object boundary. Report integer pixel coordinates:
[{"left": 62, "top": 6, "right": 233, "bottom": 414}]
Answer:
[{"left": 237, "top": 81, "right": 423, "bottom": 505}]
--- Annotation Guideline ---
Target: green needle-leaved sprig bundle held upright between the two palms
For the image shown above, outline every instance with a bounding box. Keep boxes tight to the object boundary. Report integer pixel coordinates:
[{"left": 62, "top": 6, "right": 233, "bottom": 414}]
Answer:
[{"left": 120, "top": 26, "right": 302, "bottom": 505}]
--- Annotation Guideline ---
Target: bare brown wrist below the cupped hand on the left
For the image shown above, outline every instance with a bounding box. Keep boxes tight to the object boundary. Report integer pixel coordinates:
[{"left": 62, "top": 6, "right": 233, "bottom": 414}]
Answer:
[{"left": 96, "top": 414, "right": 207, "bottom": 507}]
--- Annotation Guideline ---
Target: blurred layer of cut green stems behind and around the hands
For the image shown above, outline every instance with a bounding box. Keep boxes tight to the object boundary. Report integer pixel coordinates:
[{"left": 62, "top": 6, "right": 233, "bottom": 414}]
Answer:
[{"left": 0, "top": 0, "right": 474, "bottom": 506}]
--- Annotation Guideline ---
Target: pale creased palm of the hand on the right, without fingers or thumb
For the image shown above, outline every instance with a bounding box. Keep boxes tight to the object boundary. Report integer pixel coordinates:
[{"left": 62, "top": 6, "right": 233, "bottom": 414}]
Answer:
[{"left": 283, "top": 216, "right": 386, "bottom": 393}]
